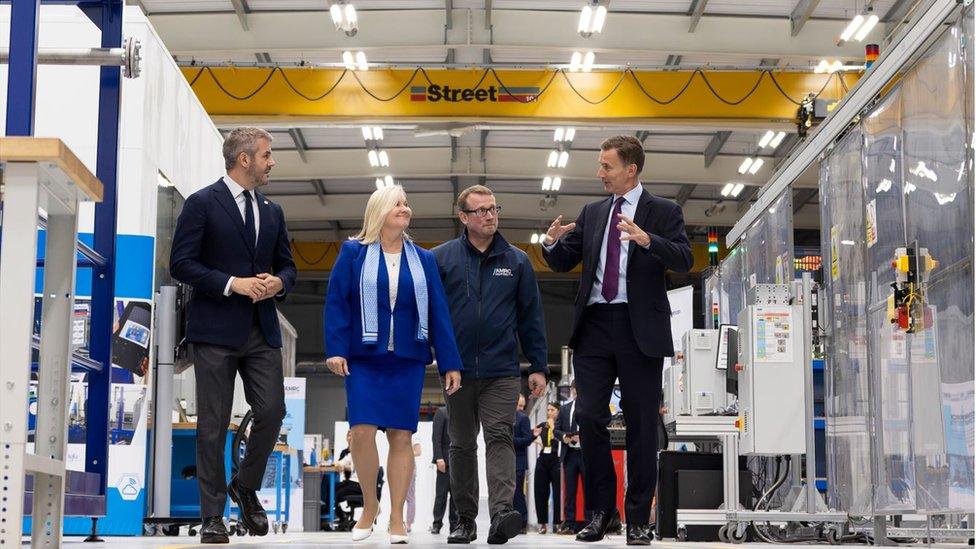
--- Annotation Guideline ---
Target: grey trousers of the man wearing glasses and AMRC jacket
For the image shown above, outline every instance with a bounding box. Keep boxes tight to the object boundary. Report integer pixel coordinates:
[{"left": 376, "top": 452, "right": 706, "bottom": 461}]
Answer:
[{"left": 447, "top": 374, "right": 521, "bottom": 520}]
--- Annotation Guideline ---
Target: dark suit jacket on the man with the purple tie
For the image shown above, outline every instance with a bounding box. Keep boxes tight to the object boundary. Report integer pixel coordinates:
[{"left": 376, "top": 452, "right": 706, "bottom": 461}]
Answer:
[{"left": 543, "top": 189, "right": 693, "bottom": 357}]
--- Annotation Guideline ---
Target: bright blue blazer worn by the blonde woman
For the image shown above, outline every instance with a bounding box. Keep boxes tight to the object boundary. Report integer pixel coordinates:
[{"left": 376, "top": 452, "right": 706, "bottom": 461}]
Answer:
[{"left": 323, "top": 240, "right": 463, "bottom": 374}]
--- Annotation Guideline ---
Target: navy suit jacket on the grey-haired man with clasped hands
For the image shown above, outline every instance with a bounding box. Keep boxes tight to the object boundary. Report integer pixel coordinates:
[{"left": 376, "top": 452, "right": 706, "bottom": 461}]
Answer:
[{"left": 169, "top": 179, "right": 296, "bottom": 348}]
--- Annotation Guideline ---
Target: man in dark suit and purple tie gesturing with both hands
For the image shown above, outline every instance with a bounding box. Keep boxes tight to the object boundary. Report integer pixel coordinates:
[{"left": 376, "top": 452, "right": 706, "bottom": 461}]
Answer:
[{"left": 543, "top": 136, "right": 692, "bottom": 545}]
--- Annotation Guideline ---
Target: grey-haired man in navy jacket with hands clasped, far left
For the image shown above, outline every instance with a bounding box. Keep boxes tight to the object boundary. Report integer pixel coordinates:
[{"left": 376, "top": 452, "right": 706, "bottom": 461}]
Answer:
[{"left": 170, "top": 128, "right": 296, "bottom": 543}]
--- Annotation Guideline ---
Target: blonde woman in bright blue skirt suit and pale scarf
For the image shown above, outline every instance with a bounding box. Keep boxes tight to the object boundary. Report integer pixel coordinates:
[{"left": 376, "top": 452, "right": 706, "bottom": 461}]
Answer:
[{"left": 325, "top": 185, "right": 462, "bottom": 543}]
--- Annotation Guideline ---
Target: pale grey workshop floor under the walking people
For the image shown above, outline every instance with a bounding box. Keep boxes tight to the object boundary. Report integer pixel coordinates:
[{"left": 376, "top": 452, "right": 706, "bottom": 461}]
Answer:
[{"left": 57, "top": 531, "right": 966, "bottom": 549}]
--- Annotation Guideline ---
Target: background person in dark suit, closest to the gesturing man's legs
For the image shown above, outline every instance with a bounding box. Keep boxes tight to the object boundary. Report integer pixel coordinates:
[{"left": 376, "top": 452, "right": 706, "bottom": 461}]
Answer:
[{"left": 555, "top": 380, "right": 589, "bottom": 534}]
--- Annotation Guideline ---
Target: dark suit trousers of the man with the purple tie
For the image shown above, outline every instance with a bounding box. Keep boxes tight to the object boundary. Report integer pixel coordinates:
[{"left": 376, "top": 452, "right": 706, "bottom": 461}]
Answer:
[{"left": 573, "top": 304, "right": 664, "bottom": 524}]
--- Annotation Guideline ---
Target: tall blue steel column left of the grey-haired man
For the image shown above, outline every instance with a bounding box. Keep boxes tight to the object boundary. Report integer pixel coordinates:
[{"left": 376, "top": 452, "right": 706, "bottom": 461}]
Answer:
[{"left": 81, "top": 0, "right": 122, "bottom": 506}]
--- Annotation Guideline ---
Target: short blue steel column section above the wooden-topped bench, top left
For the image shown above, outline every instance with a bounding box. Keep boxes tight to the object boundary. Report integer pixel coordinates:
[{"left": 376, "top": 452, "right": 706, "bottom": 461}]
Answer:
[{"left": 6, "top": 0, "right": 41, "bottom": 136}]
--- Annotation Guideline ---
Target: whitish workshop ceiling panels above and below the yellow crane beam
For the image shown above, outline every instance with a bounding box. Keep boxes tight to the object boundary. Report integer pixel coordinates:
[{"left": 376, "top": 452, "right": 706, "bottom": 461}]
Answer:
[{"left": 135, "top": 0, "right": 913, "bottom": 241}]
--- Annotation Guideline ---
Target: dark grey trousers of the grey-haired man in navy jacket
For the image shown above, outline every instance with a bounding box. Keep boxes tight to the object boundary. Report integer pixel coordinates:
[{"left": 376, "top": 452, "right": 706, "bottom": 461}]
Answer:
[{"left": 193, "top": 326, "right": 285, "bottom": 517}]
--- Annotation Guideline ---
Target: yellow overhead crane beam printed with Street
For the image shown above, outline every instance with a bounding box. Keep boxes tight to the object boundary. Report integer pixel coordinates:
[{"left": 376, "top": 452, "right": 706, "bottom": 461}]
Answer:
[{"left": 182, "top": 66, "right": 860, "bottom": 124}]
